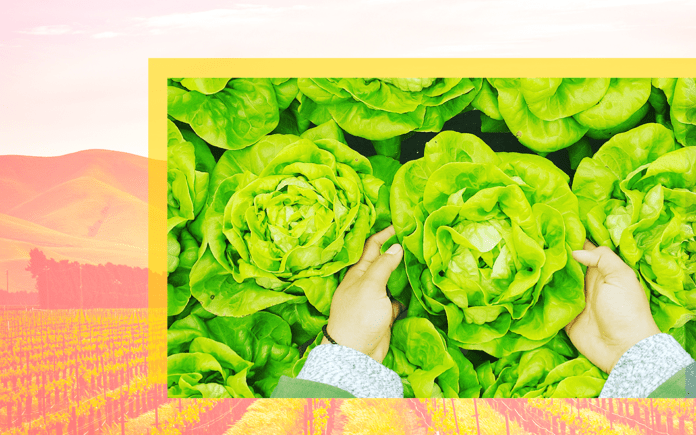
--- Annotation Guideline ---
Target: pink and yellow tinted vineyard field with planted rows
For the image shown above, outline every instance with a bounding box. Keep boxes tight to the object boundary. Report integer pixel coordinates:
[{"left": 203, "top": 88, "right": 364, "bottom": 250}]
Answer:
[{"left": 0, "top": 309, "right": 696, "bottom": 435}]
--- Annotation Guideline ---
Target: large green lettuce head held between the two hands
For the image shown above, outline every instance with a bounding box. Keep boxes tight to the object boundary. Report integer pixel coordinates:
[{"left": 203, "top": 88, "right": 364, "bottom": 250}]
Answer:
[{"left": 391, "top": 131, "right": 585, "bottom": 357}]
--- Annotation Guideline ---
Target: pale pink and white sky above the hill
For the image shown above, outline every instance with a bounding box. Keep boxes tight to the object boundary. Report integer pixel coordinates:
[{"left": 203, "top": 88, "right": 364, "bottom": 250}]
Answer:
[{"left": 0, "top": 0, "right": 696, "bottom": 156}]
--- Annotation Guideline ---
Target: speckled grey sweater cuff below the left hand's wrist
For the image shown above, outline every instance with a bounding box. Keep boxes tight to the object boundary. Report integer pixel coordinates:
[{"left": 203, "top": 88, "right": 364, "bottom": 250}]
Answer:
[{"left": 297, "top": 344, "right": 404, "bottom": 399}]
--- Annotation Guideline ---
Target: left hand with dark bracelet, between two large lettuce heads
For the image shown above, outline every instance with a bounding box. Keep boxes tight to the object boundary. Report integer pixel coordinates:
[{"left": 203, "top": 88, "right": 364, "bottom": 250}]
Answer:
[{"left": 321, "top": 227, "right": 404, "bottom": 363}]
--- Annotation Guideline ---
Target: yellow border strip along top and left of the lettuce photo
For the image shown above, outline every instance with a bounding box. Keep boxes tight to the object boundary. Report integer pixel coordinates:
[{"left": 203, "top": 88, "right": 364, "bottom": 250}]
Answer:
[{"left": 148, "top": 58, "right": 696, "bottom": 383}]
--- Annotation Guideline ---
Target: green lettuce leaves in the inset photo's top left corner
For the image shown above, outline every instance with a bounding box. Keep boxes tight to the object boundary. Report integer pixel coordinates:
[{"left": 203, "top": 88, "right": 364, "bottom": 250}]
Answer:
[{"left": 167, "top": 78, "right": 298, "bottom": 150}]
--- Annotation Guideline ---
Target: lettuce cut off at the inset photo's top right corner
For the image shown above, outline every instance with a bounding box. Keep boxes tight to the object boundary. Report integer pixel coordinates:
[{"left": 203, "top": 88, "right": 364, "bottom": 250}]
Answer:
[{"left": 650, "top": 78, "right": 696, "bottom": 146}]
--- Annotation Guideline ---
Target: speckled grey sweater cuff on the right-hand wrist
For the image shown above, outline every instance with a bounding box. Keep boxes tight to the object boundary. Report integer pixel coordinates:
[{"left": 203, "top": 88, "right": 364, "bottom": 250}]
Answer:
[{"left": 599, "top": 334, "right": 694, "bottom": 398}]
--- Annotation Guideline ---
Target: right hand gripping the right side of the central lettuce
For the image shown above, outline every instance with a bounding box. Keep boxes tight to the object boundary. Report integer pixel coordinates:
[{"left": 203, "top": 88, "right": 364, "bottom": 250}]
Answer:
[{"left": 565, "top": 241, "right": 660, "bottom": 373}]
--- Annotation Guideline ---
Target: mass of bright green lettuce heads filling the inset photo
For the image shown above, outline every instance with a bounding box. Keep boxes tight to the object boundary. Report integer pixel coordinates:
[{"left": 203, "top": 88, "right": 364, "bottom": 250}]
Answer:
[{"left": 167, "top": 78, "right": 696, "bottom": 398}]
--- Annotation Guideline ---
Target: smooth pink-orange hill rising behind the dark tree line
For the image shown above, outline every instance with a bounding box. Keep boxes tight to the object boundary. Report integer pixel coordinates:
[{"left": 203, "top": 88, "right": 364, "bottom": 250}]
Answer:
[{"left": 0, "top": 150, "right": 148, "bottom": 292}]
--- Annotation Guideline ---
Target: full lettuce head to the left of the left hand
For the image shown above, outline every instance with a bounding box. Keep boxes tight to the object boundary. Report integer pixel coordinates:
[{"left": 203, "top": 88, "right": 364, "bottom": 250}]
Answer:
[{"left": 190, "top": 122, "right": 388, "bottom": 317}]
